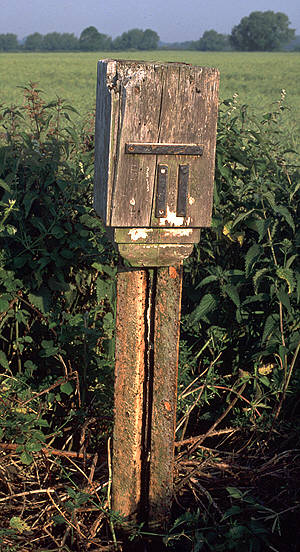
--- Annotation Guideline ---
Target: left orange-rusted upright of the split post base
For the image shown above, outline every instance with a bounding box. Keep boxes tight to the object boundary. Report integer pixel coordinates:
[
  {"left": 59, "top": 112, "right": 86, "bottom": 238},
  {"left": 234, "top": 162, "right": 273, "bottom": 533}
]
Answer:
[{"left": 112, "top": 270, "right": 147, "bottom": 519}]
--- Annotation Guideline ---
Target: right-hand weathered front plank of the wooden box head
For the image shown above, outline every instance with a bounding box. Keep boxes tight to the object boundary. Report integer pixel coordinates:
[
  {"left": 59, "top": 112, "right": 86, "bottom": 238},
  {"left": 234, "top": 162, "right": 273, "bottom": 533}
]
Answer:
[{"left": 153, "top": 64, "right": 219, "bottom": 227}]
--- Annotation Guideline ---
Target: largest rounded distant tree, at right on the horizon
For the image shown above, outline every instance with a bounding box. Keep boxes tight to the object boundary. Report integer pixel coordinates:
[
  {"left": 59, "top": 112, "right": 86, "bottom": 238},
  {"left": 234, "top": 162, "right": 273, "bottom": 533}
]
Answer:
[{"left": 230, "top": 11, "right": 295, "bottom": 52}]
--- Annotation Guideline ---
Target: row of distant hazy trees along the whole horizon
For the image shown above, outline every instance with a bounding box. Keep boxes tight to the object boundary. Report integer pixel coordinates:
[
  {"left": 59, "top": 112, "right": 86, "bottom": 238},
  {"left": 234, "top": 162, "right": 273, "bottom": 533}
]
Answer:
[{"left": 0, "top": 10, "right": 300, "bottom": 52}]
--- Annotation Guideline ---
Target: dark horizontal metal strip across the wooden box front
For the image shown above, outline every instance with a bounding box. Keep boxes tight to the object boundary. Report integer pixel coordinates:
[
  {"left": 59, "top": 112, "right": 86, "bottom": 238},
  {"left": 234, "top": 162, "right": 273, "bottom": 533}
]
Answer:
[{"left": 125, "top": 142, "right": 203, "bottom": 155}]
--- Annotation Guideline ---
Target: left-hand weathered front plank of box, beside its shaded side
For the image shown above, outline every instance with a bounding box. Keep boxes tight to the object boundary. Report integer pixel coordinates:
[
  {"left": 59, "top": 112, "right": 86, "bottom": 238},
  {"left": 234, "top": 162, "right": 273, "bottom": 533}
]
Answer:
[{"left": 111, "top": 61, "right": 162, "bottom": 227}]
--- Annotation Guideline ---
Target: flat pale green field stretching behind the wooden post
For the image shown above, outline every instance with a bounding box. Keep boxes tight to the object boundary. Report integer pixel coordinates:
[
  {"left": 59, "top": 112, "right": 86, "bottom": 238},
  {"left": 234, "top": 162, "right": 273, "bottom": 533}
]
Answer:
[{"left": 0, "top": 51, "right": 300, "bottom": 136}]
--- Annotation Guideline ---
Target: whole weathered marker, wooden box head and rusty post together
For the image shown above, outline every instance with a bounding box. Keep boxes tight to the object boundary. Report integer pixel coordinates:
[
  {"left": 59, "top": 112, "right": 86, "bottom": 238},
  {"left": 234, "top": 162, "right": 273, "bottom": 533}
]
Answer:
[{"left": 94, "top": 59, "right": 219, "bottom": 525}]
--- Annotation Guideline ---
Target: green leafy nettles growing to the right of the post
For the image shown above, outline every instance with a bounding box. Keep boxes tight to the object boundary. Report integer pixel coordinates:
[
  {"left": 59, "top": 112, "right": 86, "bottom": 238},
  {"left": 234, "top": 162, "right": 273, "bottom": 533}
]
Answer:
[{"left": 179, "top": 91, "right": 300, "bottom": 427}]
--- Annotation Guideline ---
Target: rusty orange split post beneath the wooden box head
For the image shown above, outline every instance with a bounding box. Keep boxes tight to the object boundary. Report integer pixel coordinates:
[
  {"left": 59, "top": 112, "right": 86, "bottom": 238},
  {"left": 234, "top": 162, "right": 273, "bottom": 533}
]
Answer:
[{"left": 112, "top": 265, "right": 182, "bottom": 527}]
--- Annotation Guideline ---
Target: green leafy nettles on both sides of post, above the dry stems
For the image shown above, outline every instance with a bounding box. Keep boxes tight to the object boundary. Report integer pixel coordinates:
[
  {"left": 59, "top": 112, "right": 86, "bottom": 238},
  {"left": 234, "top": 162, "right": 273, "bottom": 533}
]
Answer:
[{"left": 0, "top": 83, "right": 300, "bottom": 462}]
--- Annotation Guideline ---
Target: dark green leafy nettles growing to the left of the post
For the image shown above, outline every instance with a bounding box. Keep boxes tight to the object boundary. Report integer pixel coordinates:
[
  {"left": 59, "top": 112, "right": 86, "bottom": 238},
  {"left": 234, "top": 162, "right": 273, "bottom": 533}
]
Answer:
[{"left": 0, "top": 83, "right": 116, "bottom": 452}]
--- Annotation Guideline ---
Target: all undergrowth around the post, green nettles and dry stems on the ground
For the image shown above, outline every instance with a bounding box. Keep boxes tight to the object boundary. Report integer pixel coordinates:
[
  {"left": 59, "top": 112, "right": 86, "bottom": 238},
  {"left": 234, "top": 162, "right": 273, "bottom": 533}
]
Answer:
[{"left": 0, "top": 83, "right": 300, "bottom": 552}]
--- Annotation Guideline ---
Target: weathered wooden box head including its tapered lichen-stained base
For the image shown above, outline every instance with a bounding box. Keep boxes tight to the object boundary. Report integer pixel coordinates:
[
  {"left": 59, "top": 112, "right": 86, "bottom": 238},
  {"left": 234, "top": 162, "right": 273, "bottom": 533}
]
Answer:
[{"left": 94, "top": 59, "right": 219, "bottom": 267}]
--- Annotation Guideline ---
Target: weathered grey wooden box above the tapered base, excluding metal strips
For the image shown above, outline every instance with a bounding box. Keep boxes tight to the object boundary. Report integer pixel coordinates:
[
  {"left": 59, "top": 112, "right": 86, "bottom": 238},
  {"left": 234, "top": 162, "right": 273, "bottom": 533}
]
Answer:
[{"left": 95, "top": 60, "right": 219, "bottom": 228}]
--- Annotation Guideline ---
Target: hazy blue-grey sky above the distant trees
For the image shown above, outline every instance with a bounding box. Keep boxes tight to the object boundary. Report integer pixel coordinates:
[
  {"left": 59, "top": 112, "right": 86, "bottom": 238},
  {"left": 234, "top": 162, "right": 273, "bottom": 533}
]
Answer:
[{"left": 0, "top": 0, "right": 300, "bottom": 42}]
